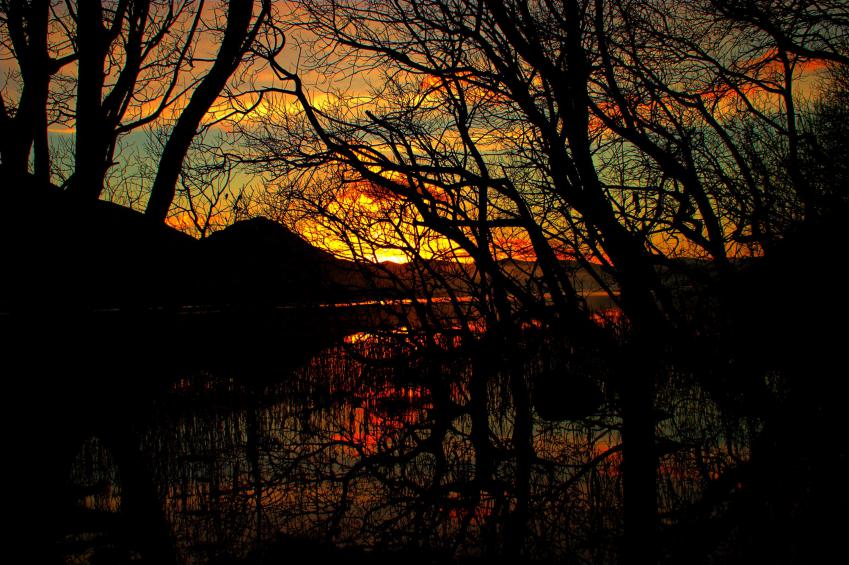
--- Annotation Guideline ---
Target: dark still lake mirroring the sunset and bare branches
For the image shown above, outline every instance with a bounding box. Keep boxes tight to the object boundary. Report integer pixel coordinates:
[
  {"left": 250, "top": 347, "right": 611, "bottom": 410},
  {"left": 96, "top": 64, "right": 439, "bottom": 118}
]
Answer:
[{"left": 1, "top": 305, "right": 757, "bottom": 564}]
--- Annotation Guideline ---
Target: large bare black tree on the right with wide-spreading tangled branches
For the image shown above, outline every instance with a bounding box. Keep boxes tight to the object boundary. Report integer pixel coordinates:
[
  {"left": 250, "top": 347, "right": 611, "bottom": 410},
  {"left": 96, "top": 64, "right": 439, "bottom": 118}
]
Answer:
[{"left": 240, "top": 0, "right": 846, "bottom": 562}]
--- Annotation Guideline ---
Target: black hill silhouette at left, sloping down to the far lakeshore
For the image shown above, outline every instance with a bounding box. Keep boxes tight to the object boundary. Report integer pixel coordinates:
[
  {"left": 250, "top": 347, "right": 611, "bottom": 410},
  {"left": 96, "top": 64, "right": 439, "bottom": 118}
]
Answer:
[{"left": 0, "top": 178, "right": 384, "bottom": 313}]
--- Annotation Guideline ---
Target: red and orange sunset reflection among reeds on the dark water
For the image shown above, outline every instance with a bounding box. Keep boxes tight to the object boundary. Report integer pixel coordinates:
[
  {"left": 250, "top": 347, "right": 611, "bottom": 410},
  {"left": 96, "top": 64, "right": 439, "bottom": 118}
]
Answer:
[{"left": 58, "top": 331, "right": 757, "bottom": 563}]
